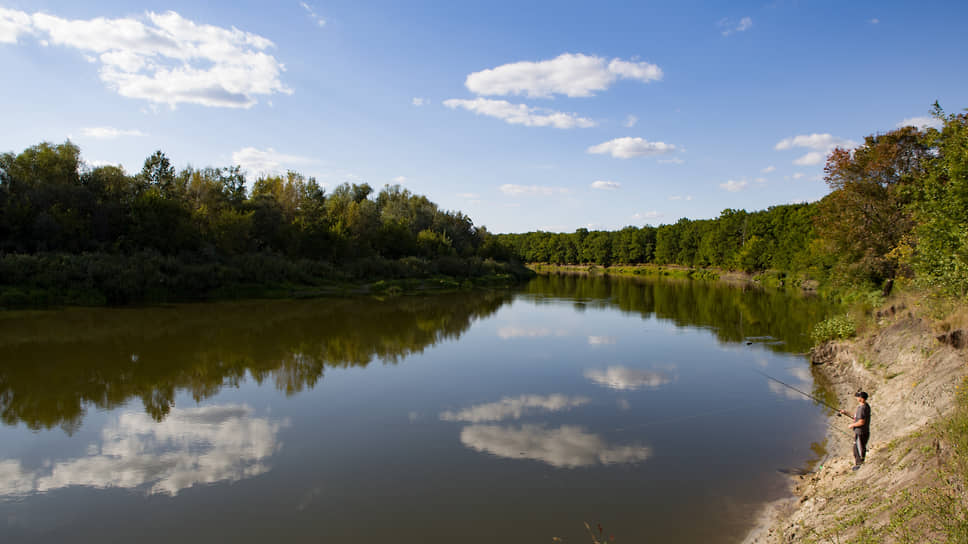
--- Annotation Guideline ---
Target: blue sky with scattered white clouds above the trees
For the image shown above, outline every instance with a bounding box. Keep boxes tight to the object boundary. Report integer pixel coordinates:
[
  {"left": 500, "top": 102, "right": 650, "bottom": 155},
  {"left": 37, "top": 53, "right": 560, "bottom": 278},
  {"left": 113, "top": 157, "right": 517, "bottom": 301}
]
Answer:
[{"left": 0, "top": 0, "right": 968, "bottom": 232}]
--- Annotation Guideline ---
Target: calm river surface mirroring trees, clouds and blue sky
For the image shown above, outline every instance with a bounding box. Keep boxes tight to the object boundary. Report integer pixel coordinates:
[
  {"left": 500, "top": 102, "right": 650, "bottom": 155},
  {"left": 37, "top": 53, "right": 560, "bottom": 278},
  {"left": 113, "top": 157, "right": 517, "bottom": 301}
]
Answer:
[{"left": 0, "top": 276, "right": 824, "bottom": 543}]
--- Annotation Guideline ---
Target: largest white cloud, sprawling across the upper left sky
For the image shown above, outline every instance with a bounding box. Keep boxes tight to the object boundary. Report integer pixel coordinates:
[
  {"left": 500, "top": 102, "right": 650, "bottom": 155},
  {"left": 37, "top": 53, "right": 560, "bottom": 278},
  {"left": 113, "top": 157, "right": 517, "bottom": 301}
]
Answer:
[{"left": 0, "top": 10, "right": 292, "bottom": 108}]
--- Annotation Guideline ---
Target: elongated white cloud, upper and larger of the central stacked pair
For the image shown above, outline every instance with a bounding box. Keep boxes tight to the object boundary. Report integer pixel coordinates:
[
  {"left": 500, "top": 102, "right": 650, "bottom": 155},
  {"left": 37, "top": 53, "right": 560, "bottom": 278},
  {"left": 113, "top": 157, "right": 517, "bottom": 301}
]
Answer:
[{"left": 465, "top": 53, "right": 662, "bottom": 98}]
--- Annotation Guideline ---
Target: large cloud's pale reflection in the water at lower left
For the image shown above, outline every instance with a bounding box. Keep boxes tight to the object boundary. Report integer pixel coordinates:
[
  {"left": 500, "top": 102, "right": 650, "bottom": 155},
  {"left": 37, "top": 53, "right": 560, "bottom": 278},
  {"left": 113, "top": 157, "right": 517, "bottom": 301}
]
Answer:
[{"left": 0, "top": 404, "right": 287, "bottom": 496}]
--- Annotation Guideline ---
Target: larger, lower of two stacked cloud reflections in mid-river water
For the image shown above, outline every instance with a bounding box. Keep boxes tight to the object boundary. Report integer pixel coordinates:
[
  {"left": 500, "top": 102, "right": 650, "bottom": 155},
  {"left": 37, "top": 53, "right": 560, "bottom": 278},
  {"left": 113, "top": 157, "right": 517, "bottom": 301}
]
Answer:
[{"left": 460, "top": 425, "right": 652, "bottom": 468}]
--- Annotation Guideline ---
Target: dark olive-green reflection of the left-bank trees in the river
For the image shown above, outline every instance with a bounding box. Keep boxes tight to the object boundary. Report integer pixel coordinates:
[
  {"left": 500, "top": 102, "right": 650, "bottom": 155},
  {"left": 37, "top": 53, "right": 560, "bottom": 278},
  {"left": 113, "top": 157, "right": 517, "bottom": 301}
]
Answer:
[{"left": 0, "top": 291, "right": 511, "bottom": 434}]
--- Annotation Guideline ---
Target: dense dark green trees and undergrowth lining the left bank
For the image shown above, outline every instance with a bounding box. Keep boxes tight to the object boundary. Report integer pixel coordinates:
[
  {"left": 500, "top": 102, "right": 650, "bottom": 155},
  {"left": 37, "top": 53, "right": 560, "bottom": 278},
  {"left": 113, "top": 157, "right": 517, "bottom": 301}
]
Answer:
[{"left": 0, "top": 141, "right": 526, "bottom": 306}]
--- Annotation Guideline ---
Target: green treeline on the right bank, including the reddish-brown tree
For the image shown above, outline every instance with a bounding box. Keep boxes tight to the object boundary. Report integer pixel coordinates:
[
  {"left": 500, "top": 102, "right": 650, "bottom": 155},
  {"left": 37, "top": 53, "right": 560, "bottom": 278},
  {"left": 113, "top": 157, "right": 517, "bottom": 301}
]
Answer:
[{"left": 500, "top": 103, "right": 968, "bottom": 297}]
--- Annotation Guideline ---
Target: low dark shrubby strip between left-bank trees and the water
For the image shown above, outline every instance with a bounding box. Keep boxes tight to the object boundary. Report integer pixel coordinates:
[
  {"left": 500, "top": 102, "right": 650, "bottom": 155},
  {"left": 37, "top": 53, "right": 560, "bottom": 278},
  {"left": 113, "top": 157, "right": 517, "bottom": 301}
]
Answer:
[{"left": 0, "top": 252, "right": 533, "bottom": 308}]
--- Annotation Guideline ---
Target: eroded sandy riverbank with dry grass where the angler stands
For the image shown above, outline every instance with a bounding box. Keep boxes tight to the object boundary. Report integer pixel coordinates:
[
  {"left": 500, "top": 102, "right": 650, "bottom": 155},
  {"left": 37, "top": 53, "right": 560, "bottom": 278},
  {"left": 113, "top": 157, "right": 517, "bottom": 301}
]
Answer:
[{"left": 744, "top": 296, "right": 968, "bottom": 544}]
